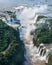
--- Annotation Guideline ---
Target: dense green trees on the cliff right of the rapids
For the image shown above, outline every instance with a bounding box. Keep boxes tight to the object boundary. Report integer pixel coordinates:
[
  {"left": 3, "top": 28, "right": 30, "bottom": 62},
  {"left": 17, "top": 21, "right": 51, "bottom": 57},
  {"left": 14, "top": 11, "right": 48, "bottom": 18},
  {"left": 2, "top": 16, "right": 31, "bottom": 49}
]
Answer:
[{"left": 34, "top": 18, "right": 52, "bottom": 43}]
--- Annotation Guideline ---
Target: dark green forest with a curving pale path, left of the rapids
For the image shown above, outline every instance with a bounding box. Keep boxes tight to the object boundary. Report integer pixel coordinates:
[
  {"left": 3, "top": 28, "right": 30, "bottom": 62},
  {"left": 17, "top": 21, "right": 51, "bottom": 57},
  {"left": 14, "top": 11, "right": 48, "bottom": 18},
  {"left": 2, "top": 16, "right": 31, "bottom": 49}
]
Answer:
[{"left": 0, "top": 20, "right": 24, "bottom": 65}]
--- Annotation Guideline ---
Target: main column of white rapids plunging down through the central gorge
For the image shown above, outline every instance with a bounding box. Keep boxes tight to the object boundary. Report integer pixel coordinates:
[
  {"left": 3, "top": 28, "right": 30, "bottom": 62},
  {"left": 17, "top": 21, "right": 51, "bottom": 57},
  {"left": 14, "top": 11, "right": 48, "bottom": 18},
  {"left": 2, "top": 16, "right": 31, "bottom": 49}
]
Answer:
[{"left": 1, "top": 5, "right": 52, "bottom": 65}]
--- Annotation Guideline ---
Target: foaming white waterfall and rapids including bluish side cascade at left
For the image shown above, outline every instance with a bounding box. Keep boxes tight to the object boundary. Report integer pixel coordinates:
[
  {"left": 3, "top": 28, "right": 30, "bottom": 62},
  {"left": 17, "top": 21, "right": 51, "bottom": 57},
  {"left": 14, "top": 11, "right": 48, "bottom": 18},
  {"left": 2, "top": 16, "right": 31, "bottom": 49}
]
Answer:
[{"left": 1, "top": 5, "right": 52, "bottom": 65}]
